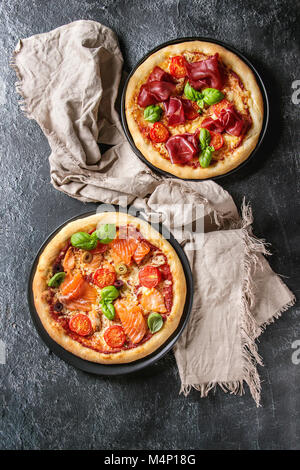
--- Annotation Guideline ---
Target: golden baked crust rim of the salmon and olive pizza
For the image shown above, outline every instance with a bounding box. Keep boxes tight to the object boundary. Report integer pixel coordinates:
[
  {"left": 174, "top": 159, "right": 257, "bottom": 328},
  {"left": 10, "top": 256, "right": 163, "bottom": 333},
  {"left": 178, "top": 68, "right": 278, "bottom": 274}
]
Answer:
[{"left": 32, "top": 212, "right": 186, "bottom": 364}]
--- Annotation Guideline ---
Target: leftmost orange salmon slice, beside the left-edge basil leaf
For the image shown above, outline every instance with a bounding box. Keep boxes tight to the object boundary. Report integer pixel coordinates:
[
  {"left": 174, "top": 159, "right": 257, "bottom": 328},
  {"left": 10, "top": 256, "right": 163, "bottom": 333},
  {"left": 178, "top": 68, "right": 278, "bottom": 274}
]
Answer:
[{"left": 60, "top": 273, "right": 98, "bottom": 312}]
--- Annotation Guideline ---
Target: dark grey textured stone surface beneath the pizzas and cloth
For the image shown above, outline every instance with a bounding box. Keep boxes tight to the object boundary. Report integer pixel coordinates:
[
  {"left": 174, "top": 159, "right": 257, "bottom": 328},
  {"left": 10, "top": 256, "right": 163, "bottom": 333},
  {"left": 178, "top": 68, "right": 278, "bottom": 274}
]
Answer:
[{"left": 0, "top": 0, "right": 300, "bottom": 449}]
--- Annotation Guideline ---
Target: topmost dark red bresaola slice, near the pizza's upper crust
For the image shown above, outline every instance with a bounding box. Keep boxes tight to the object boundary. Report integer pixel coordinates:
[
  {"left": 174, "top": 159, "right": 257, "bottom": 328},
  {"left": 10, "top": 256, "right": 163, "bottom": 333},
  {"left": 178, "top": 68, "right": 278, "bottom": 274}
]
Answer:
[{"left": 186, "top": 53, "right": 223, "bottom": 90}]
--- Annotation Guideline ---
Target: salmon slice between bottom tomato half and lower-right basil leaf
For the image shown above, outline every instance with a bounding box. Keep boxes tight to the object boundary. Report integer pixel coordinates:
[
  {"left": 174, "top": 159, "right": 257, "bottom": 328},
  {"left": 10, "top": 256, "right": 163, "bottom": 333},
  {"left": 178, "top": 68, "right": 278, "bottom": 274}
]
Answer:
[{"left": 114, "top": 299, "right": 147, "bottom": 344}]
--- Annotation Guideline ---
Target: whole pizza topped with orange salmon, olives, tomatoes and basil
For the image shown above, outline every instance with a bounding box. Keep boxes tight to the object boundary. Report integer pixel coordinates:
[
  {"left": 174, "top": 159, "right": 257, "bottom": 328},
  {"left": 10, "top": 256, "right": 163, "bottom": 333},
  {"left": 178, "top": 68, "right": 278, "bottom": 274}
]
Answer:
[{"left": 33, "top": 212, "right": 186, "bottom": 364}]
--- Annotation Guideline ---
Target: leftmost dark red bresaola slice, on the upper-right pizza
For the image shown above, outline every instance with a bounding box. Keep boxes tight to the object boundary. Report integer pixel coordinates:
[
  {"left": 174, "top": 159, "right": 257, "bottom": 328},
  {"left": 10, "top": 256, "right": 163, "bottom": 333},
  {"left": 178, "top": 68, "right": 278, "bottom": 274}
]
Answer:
[{"left": 138, "top": 67, "right": 176, "bottom": 108}]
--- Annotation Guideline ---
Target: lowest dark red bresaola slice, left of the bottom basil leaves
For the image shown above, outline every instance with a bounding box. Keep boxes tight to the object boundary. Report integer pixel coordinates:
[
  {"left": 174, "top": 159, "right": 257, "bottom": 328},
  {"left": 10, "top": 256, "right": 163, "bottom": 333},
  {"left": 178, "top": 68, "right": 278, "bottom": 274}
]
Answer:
[{"left": 165, "top": 130, "right": 199, "bottom": 164}]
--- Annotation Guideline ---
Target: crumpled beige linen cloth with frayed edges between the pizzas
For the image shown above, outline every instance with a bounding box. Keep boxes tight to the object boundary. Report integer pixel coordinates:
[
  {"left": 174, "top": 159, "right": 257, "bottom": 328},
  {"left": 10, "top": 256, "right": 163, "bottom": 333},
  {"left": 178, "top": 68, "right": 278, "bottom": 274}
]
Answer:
[{"left": 12, "top": 21, "right": 295, "bottom": 405}]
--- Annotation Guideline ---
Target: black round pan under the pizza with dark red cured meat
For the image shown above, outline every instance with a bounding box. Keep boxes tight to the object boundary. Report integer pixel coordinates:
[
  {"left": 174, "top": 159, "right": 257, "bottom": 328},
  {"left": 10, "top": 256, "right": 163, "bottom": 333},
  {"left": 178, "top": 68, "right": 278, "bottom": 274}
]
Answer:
[{"left": 121, "top": 37, "right": 269, "bottom": 181}]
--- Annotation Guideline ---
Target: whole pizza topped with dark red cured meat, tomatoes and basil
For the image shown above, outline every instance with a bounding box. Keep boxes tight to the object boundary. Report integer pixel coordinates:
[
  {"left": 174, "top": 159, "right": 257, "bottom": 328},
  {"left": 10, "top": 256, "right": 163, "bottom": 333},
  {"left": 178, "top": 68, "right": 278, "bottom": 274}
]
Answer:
[{"left": 125, "top": 41, "right": 263, "bottom": 179}]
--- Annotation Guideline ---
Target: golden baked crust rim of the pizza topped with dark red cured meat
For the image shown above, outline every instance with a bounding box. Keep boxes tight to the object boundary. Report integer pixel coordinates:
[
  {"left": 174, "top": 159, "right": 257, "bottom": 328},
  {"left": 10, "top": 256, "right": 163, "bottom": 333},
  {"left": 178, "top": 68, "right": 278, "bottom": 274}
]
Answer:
[{"left": 125, "top": 41, "right": 264, "bottom": 179}]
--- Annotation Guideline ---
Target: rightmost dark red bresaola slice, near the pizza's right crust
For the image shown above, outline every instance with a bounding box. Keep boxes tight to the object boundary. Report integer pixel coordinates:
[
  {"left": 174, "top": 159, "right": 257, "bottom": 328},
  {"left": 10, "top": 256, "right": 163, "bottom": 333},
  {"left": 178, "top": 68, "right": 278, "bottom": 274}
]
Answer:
[{"left": 201, "top": 105, "right": 246, "bottom": 137}]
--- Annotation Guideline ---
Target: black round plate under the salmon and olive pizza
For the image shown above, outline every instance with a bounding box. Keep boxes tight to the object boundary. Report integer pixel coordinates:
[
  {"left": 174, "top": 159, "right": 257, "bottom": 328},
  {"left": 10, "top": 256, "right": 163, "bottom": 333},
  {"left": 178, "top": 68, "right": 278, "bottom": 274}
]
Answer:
[{"left": 27, "top": 208, "right": 193, "bottom": 375}]
